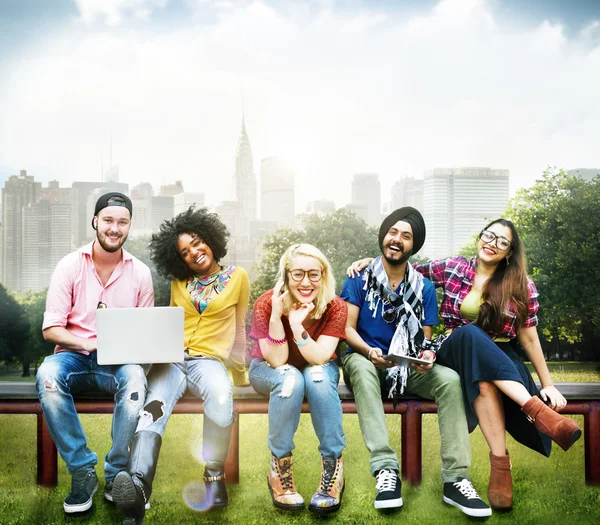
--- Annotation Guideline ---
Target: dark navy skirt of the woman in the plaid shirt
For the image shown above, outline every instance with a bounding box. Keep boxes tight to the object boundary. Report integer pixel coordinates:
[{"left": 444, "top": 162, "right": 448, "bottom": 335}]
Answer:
[{"left": 437, "top": 324, "right": 552, "bottom": 456}]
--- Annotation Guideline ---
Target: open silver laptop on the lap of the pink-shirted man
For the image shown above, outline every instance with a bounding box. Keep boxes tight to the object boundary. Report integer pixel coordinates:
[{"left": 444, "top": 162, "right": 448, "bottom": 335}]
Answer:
[{"left": 96, "top": 306, "right": 184, "bottom": 365}]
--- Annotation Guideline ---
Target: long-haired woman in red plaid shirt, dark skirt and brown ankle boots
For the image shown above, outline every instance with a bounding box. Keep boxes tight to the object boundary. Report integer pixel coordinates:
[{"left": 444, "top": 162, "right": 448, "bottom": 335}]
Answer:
[{"left": 348, "top": 219, "right": 581, "bottom": 509}]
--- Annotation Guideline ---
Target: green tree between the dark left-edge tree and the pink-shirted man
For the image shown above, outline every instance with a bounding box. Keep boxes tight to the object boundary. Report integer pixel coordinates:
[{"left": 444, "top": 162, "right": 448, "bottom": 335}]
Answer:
[{"left": 15, "top": 289, "right": 54, "bottom": 377}]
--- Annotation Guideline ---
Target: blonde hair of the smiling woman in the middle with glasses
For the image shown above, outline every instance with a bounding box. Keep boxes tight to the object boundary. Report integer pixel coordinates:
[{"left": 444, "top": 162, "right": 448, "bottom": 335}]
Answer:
[{"left": 277, "top": 244, "right": 335, "bottom": 319}]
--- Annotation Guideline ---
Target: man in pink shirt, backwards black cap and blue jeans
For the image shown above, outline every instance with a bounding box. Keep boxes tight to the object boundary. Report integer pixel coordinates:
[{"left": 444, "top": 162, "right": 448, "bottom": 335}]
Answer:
[{"left": 36, "top": 193, "right": 154, "bottom": 513}]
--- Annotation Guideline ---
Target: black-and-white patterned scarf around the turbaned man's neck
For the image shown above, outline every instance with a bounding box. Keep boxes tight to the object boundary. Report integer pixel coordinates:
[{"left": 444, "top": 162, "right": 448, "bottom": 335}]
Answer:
[{"left": 363, "top": 256, "right": 424, "bottom": 398}]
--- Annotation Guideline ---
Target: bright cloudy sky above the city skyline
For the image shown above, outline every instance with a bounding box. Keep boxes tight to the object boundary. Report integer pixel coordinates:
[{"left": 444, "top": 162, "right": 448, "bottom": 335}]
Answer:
[{"left": 0, "top": 0, "right": 600, "bottom": 211}]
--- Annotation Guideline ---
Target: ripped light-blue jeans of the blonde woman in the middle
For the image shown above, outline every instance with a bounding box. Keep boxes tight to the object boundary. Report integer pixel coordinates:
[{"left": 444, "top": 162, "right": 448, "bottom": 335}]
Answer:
[{"left": 250, "top": 358, "right": 346, "bottom": 459}]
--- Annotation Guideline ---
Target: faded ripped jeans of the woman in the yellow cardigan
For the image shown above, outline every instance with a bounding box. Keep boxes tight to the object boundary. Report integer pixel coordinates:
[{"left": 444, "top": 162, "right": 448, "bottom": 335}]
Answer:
[{"left": 136, "top": 354, "right": 234, "bottom": 464}]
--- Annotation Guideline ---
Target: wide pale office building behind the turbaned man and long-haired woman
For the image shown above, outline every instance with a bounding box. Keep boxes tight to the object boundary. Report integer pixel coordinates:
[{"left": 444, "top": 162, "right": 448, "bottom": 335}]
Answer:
[{"left": 420, "top": 168, "right": 508, "bottom": 258}]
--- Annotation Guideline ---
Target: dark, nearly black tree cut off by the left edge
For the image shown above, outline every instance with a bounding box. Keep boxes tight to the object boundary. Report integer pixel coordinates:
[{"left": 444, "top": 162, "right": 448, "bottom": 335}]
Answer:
[{"left": 0, "top": 284, "right": 29, "bottom": 372}]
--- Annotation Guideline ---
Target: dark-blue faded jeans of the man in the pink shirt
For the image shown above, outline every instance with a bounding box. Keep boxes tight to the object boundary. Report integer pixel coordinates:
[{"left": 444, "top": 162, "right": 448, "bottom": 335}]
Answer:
[{"left": 36, "top": 352, "right": 146, "bottom": 481}]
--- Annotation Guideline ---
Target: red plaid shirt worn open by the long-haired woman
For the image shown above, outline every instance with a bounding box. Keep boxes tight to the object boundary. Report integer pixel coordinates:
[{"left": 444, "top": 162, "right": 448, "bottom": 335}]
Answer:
[{"left": 413, "top": 256, "right": 540, "bottom": 339}]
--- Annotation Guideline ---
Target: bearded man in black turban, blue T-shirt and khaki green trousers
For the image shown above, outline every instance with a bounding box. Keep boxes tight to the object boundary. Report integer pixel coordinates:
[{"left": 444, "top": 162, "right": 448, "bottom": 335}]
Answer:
[{"left": 341, "top": 207, "right": 492, "bottom": 517}]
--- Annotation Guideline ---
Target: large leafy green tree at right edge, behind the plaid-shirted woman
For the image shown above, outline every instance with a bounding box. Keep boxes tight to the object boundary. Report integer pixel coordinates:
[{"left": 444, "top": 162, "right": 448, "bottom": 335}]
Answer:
[{"left": 507, "top": 169, "right": 600, "bottom": 360}]
